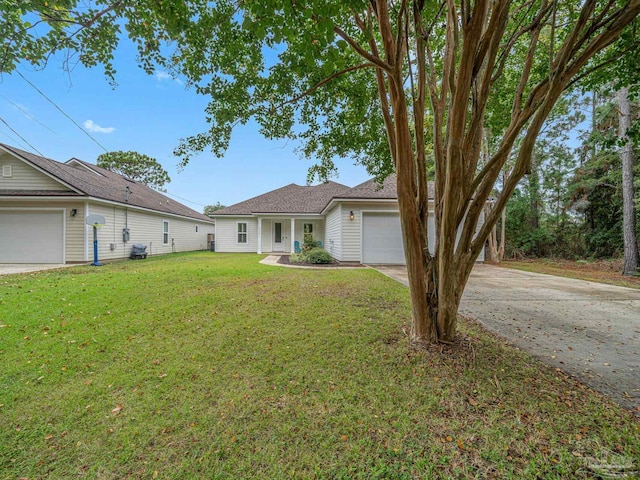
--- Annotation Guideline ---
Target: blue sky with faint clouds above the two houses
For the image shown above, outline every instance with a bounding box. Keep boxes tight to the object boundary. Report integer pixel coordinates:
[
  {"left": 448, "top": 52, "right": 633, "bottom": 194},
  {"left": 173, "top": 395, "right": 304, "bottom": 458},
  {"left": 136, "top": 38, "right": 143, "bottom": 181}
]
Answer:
[{"left": 0, "top": 45, "right": 369, "bottom": 211}]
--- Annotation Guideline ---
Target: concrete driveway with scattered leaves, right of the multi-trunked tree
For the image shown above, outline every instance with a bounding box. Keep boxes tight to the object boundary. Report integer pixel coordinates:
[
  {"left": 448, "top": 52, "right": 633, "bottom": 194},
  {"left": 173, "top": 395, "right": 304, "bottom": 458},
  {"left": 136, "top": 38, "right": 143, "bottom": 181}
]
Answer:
[{"left": 379, "top": 264, "right": 640, "bottom": 415}]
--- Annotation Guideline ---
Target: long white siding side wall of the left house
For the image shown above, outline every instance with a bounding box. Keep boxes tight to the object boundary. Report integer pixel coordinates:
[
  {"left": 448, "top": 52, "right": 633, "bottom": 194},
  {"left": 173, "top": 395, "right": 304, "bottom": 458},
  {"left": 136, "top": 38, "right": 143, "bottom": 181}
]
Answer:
[{"left": 86, "top": 203, "right": 214, "bottom": 260}]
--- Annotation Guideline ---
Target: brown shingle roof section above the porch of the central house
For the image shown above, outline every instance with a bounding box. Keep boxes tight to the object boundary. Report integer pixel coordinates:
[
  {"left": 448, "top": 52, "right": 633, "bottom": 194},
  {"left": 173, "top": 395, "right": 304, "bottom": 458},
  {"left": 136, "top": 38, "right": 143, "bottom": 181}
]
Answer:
[{"left": 214, "top": 182, "right": 349, "bottom": 216}]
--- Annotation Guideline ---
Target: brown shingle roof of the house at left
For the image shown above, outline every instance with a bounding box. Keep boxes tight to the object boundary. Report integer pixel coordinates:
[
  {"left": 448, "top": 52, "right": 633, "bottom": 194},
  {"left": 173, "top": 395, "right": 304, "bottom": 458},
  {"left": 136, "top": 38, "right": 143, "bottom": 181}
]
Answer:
[{"left": 0, "top": 143, "right": 212, "bottom": 222}]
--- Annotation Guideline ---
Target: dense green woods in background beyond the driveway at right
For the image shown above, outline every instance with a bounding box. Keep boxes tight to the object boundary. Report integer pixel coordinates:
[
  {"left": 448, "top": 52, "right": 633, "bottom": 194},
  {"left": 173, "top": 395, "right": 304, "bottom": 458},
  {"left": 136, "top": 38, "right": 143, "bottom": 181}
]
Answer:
[{"left": 494, "top": 89, "right": 640, "bottom": 260}]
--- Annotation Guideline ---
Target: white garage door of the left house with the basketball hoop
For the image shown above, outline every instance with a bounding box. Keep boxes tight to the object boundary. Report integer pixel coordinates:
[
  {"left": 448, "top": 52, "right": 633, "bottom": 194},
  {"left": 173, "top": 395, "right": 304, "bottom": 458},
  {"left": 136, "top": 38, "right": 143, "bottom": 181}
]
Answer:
[{"left": 0, "top": 210, "right": 64, "bottom": 263}]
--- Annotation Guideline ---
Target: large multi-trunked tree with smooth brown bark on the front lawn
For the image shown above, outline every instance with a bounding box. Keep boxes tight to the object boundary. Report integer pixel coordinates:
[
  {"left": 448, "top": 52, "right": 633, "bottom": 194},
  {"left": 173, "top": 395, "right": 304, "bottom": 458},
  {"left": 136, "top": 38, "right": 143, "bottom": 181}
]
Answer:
[{"left": 0, "top": 0, "right": 640, "bottom": 344}]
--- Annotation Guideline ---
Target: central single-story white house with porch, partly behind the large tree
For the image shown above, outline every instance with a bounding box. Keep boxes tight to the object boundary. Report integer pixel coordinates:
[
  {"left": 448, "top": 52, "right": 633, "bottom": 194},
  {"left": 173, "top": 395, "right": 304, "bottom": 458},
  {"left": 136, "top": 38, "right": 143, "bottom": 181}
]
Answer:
[{"left": 212, "top": 176, "right": 484, "bottom": 264}]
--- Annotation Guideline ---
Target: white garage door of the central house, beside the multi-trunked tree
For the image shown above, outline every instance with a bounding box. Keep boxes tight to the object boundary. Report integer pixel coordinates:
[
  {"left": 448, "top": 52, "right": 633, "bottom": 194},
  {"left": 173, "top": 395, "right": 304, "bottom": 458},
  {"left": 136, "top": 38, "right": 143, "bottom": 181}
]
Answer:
[{"left": 362, "top": 212, "right": 405, "bottom": 265}]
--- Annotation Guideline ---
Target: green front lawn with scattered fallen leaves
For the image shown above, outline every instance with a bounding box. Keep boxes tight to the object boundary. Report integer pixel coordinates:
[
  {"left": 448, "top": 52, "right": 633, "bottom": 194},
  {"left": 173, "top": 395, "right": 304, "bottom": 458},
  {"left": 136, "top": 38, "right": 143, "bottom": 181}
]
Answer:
[{"left": 0, "top": 252, "right": 640, "bottom": 479}]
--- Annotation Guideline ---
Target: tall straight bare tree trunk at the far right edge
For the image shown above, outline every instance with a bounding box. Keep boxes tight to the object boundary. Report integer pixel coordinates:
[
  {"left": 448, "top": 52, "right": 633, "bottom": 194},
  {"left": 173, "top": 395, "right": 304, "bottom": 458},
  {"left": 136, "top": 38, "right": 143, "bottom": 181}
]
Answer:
[{"left": 618, "top": 87, "right": 638, "bottom": 275}]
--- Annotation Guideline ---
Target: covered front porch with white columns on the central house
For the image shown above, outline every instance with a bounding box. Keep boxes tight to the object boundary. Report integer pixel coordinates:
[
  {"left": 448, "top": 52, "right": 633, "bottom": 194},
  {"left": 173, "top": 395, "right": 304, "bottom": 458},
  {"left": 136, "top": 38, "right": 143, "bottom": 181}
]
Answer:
[{"left": 257, "top": 215, "right": 325, "bottom": 254}]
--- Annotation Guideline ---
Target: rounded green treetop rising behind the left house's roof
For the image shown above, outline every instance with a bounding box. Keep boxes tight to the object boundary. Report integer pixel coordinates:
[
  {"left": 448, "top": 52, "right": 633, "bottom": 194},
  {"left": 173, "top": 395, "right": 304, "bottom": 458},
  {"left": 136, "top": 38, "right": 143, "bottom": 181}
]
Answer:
[{"left": 98, "top": 151, "right": 171, "bottom": 190}]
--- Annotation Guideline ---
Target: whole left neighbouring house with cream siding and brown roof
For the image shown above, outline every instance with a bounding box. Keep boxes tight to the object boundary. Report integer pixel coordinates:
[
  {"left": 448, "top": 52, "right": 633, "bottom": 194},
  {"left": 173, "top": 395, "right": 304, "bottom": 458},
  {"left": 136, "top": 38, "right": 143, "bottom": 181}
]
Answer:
[{"left": 0, "top": 144, "right": 215, "bottom": 263}]
